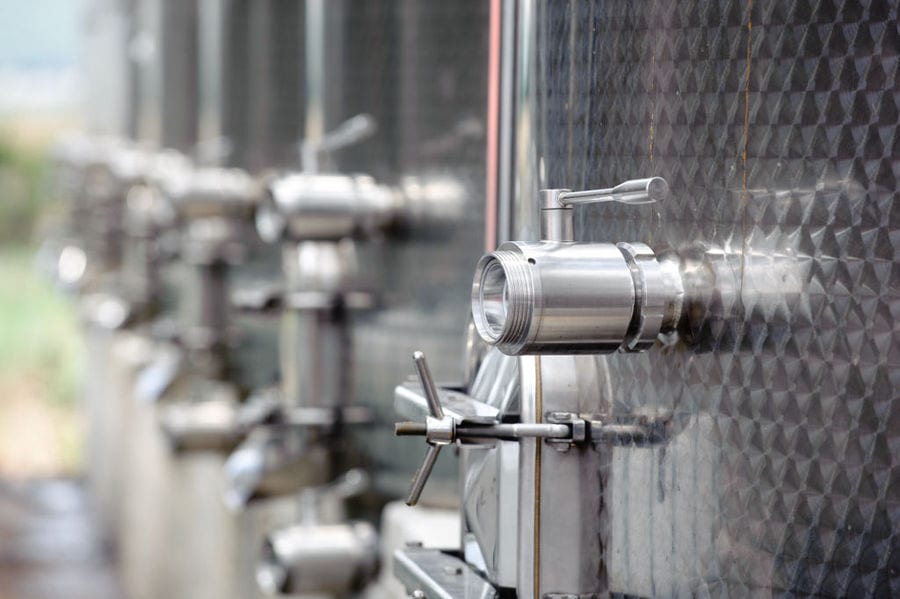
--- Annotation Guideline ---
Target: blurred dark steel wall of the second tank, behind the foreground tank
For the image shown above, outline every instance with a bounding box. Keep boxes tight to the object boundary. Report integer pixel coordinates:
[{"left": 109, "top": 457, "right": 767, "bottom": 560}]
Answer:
[{"left": 311, "top": 0, "right": 489, "bottom": 497}]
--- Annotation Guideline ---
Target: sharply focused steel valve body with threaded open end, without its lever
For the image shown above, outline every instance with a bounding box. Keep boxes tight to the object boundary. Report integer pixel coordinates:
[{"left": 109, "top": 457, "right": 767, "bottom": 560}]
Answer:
[{"left": 472, "top": 242, "right": 683, "bottom": 355}]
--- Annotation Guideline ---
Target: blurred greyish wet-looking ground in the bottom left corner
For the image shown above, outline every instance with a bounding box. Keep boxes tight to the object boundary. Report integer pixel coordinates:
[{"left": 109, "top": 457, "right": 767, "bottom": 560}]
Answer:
[{"left": 0, "top": 478, "right": 122, "bottom": 599}]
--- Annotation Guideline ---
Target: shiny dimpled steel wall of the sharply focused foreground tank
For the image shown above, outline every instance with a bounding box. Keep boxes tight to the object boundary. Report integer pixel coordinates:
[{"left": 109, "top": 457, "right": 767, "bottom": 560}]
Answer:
[{"left": 514, "top": 0, "right": 900, "bottom": 597}]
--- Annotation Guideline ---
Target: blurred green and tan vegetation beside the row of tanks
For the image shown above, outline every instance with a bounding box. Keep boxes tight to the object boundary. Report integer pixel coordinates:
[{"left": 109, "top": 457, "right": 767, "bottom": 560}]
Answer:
[{"left": 0, "top": 124, "right": 83, "bottom": 476}]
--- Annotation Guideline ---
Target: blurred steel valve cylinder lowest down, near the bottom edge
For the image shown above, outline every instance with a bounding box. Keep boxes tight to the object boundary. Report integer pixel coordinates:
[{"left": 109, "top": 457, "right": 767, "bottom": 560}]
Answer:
[{"left": 256, "top": 522, "right": 378, "bottom": 596}]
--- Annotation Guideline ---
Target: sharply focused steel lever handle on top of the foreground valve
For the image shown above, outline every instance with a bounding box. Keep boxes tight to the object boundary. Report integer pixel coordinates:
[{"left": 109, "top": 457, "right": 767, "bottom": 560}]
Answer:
[{"left": 540, "top": 177, "right": 669, "bottom": 241}]
